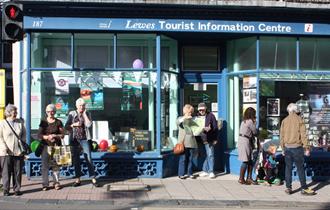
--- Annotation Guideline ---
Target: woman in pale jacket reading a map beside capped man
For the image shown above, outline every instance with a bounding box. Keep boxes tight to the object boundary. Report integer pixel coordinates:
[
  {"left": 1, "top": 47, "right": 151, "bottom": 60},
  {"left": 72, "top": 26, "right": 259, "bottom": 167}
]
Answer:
[{"left": 176, "top": 104, "right": 197, "bottom": 179}]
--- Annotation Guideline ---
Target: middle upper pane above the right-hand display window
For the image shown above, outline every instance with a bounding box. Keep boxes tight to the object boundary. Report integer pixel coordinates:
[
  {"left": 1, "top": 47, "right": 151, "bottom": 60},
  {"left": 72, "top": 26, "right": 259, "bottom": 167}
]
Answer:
[{"left": 260, "top": 37, "right": 297, "bottom": 70}]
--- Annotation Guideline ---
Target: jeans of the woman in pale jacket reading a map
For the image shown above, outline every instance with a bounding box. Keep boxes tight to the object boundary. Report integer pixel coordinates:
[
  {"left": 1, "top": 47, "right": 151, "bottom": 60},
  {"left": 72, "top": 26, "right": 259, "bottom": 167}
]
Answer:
[{"left": 178, "top": 148, "right": 195, "bottom": 176}]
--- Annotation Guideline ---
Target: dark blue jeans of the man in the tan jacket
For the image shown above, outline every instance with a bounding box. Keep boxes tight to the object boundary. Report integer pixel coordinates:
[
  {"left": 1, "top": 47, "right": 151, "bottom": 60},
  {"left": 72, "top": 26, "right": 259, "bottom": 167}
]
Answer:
[{"left": 284, "top": 147, "right": 307, "bottom": 189}]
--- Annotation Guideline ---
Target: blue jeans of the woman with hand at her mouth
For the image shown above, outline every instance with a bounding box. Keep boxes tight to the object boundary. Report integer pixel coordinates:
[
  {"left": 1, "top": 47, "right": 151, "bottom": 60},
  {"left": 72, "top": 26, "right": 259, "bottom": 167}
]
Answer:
[{"left": 72, "top": 140, "right": 95, "bottom": 178}]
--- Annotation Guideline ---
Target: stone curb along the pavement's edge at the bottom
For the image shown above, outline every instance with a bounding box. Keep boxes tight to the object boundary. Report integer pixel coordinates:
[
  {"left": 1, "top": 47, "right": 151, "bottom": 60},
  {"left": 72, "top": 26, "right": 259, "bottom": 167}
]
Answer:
[{"left": 0, "top": 197, "right": 330, "bottom": 209}]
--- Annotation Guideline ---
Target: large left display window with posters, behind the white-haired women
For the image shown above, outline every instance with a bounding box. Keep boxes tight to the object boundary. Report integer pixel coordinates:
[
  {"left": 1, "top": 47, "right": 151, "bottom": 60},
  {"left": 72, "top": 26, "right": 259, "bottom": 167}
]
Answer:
[{"left": 31, "top": 71, "right": 157, "bottom": 151}]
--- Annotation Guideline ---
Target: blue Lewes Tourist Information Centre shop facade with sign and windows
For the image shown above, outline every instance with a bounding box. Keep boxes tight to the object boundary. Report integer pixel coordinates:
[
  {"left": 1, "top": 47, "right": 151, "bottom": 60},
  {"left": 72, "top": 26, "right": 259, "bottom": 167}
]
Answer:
[{"left": 19, "top": 6, "right": 330, "bottom": 179}]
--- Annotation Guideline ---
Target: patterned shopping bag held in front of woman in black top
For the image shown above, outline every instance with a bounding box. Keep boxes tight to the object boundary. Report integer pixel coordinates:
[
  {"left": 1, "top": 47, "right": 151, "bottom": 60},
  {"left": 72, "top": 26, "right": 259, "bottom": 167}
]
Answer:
[{"left": 52, "top": 145, "right": 72, "bottom": 166}]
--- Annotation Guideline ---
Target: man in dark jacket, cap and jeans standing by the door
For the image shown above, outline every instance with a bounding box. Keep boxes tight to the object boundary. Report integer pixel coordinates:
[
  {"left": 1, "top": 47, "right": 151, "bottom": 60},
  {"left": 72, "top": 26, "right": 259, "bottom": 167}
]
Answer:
[{"left": 198, "top": 103, "right": 219, "bottom": 179}]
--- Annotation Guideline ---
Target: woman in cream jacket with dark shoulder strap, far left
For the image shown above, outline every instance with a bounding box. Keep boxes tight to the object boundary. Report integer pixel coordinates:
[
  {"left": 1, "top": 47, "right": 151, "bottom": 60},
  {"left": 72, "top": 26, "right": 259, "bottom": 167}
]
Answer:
[{"left": 0, "top": 104, "right": 26, "bottom": 196}]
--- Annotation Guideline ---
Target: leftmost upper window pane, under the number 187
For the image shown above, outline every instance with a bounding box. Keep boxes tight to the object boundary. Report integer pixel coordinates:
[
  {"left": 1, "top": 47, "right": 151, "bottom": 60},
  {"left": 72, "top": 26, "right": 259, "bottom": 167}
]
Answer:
[{"left": 31, "top": 33, "right": 71, "bottom": 68}]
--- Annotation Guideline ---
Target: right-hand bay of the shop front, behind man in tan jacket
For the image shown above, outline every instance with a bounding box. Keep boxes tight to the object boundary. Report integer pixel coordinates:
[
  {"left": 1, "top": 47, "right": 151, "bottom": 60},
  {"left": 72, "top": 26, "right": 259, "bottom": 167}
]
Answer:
[{"left": 228, "top": 36, "right": 330, "bottom": 180}]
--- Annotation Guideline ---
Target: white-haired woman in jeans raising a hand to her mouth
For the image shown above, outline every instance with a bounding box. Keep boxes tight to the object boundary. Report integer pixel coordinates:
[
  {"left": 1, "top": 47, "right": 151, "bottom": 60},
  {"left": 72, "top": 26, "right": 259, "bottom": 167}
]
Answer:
[{"left": 65, "top": 98, "right": 99, "bottom": 187}]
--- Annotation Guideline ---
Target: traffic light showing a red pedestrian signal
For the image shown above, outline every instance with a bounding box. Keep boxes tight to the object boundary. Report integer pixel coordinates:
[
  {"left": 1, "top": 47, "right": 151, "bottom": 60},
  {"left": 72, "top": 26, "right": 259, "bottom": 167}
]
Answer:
[{"left": 2, "top": 2, "right": 23, "bottom": 42}]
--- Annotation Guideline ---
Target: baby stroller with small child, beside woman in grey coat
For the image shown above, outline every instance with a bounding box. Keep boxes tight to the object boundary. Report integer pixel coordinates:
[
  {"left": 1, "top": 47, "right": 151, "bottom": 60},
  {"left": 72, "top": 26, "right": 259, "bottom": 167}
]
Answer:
[{"left": 255, "top": 144, "right": 281, "bottom": 186}]
